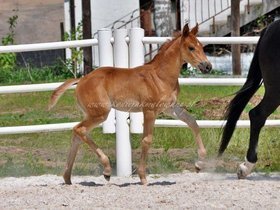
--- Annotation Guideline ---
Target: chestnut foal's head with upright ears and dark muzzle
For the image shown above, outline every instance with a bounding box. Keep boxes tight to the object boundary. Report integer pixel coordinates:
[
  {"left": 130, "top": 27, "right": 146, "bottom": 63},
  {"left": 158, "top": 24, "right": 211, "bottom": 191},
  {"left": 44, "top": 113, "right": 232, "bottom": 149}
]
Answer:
[{"left": 180, "top": 24, "right": 212, "bottom": 73}]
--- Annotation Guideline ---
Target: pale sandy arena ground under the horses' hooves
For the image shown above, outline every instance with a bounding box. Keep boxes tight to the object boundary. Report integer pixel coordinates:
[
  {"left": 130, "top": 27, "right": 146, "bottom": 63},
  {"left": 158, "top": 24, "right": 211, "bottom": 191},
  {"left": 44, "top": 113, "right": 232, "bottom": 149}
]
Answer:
[{"left": 0, "top": 172, "right": 280, "bottom": 209}]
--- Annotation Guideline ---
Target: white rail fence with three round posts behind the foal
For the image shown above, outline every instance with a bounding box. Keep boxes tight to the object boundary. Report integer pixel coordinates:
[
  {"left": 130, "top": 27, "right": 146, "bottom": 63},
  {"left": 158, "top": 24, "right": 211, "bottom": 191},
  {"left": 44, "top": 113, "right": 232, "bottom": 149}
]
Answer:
[{"left": 0, "top": 28, "right": 280, "bottom": 176}]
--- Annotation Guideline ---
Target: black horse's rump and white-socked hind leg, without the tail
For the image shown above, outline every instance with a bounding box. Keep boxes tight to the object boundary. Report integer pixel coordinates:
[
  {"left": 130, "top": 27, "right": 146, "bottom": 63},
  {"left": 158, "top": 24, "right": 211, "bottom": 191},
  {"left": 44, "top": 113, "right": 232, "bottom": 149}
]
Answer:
[{"left": 240, "top": 21, "right": 280, "bottom": 178}]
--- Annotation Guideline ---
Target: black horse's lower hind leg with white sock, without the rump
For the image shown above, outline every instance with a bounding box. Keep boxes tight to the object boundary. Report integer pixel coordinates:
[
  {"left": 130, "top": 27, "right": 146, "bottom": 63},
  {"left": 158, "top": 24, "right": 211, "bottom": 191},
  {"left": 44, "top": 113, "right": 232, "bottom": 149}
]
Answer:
[{"left": 237, "top": 93, "right": 280, "bottom": 179}]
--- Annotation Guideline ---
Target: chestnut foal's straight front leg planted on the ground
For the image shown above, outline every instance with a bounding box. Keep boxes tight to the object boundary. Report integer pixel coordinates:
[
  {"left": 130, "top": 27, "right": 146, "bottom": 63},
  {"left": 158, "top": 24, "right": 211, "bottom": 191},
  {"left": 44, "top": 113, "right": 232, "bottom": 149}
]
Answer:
[{"left": 138, "top": 111, "right": 156, "bottom": 185}]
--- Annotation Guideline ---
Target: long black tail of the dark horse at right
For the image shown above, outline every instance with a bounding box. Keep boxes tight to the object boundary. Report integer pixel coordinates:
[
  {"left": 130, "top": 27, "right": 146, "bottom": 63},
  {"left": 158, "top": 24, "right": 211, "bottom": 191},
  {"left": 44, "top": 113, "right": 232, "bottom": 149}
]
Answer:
[{"left": 219, "top": 30, "right": 265, "bottom": 156}]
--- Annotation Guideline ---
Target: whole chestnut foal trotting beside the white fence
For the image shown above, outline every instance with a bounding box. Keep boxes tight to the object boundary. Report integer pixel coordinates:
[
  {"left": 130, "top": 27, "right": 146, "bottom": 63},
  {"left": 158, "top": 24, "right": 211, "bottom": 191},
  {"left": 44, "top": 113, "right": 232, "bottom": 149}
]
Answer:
[{"left": 49, "top": 24, "right": 211, "bottom": 184}]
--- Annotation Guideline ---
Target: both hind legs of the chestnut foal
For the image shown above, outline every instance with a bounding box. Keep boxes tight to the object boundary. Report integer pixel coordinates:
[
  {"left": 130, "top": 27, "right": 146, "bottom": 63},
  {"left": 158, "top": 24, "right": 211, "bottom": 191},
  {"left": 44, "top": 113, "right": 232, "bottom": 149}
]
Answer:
[{"left": 63, "top": 116, "right": 112, "bottom": 184}]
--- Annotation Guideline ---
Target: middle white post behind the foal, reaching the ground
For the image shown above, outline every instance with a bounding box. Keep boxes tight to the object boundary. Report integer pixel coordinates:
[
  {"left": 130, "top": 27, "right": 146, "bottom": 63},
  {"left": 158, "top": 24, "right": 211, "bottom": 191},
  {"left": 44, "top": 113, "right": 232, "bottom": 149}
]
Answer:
[{"left": 114, "top": 29, "right": 132, "bottom": 176}]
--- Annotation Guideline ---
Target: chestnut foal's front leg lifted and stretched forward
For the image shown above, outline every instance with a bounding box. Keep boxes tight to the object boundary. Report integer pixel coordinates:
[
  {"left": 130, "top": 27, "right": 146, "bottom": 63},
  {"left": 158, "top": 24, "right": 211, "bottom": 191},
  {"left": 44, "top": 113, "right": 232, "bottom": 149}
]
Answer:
[{"left": 164, "top": 104, "right": 206, "bottom": 170}]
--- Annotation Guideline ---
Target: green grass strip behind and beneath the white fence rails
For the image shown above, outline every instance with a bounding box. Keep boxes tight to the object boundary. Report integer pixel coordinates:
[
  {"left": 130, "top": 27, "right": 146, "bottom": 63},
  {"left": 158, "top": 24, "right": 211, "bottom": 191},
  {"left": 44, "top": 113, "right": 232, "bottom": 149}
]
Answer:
[{"left": 0, "top": 86, "right": 280, "bottom": 176}]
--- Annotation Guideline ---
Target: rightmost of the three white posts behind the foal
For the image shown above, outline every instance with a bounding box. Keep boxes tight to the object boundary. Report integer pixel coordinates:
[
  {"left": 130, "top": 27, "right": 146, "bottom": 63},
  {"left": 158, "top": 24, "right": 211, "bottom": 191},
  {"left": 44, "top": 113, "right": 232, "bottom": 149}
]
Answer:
[{"left": 129, "top": 28, "right": 145, "bottom": 133}]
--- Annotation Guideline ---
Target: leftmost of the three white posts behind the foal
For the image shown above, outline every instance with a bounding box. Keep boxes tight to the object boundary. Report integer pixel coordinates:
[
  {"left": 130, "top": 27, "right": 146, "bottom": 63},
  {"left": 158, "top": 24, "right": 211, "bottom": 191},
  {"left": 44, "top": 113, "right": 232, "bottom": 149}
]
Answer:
[{"left": 98, "top": 28, "right": 116, "bottom": 133}]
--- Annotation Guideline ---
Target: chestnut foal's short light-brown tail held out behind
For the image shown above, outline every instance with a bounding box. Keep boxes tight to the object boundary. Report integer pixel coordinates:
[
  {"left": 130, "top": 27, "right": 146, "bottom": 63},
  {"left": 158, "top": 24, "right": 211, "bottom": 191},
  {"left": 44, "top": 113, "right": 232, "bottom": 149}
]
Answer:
[{"left": 48, "top": 78, "right": 80, "bottom": 110}]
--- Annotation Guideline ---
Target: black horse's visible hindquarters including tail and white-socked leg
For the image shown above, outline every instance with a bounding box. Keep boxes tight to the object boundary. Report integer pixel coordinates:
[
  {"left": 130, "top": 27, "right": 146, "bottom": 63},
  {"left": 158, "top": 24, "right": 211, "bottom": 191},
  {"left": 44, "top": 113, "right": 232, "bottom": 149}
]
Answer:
[{"left": 219, "top": 20, "right": 280, "bottom": 178}]
